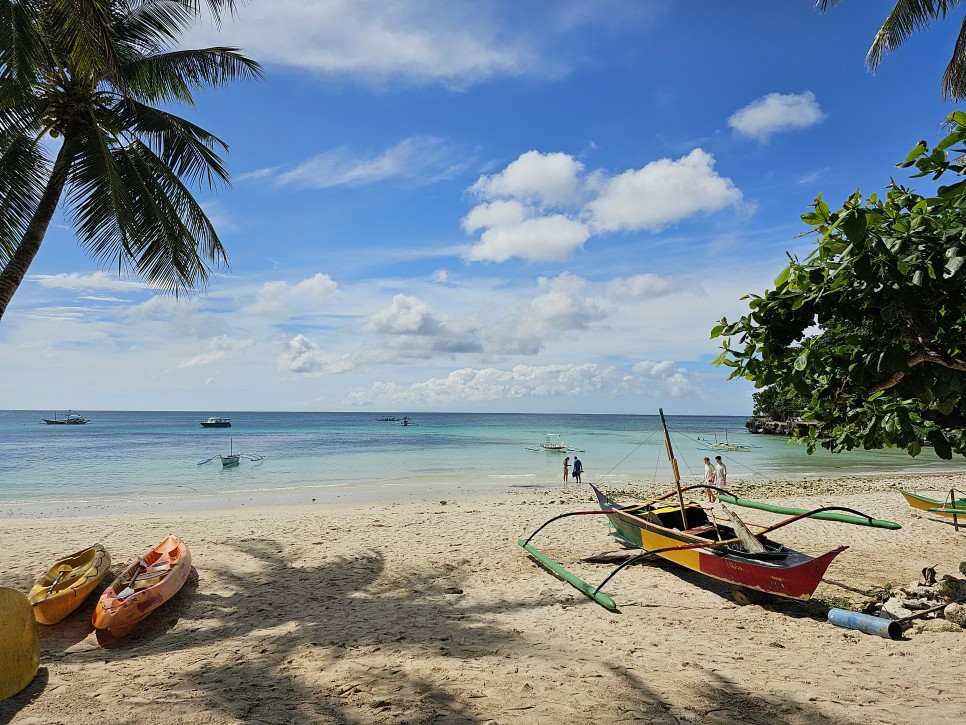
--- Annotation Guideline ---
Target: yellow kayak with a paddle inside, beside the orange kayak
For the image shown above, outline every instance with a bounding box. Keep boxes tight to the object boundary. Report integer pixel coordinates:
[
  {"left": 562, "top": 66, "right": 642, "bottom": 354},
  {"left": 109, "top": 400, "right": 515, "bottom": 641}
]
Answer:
[{"left": 27, "top": 544, "right": 111, "bottom": 624}]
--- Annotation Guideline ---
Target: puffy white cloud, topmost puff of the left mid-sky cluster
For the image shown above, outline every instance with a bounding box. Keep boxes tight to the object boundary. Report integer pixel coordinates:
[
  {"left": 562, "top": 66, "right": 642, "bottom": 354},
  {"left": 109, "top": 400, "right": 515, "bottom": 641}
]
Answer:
[{"left": 471, "top": 151, "right": 584, "bottom": 206}]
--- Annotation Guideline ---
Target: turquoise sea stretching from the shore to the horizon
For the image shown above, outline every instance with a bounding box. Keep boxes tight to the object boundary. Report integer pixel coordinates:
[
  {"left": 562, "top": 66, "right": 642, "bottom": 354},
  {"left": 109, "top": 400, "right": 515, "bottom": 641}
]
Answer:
[{"left": 0, "top": 411, "right": 963, "bottom": 516}]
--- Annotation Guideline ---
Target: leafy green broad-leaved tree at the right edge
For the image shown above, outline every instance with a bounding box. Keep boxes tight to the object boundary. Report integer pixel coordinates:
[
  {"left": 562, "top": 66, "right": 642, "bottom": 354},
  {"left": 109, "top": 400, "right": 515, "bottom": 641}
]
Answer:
[{"left": 711, "top": 112, "right": 966, "bottom": 459}]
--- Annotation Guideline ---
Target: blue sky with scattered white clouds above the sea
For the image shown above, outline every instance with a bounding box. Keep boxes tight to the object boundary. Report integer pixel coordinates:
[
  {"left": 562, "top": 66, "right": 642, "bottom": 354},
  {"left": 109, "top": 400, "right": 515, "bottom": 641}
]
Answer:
[{"left": 0, "top": 0, "right": 963, "bottom": 415}]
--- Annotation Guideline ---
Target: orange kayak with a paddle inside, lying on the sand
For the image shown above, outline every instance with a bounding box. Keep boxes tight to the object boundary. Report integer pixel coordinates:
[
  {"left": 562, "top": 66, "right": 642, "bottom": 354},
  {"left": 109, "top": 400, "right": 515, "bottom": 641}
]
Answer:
[{"left": 92, "top": 534, "right": 191, "bottom": 637}]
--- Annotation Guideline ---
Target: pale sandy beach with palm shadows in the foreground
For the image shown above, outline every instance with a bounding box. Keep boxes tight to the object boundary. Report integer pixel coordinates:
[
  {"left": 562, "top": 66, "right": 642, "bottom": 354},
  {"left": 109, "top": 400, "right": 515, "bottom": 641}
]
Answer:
[{"left": 0, "top": 476, "right": 966, "bottom": 725}]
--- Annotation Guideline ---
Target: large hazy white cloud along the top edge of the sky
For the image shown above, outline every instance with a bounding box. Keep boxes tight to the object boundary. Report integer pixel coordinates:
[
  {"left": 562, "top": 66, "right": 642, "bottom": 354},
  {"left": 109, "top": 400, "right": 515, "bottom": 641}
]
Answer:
[{"left": 190, "top": 0, "right": 541, "bottom": 87}]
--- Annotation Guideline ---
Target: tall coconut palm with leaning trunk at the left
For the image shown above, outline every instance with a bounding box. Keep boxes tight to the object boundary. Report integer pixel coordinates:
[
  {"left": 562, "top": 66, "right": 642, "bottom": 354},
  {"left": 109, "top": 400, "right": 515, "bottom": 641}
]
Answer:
[{"left": 0, "top": 0, "right": 261, "bottom": 318}]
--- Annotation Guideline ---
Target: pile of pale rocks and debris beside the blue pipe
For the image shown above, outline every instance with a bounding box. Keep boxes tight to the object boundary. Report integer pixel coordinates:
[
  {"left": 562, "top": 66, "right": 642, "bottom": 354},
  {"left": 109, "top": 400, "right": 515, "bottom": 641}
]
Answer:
[{"left": 865, "top": 561, "right": 966, "bottom": 631}]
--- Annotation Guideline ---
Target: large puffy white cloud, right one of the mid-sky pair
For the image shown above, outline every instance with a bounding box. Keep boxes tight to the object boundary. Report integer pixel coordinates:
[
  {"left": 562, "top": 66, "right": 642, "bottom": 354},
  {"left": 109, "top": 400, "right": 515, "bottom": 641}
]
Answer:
[{"left": 586, "top": 149, "right": 741, "bottom": 232}]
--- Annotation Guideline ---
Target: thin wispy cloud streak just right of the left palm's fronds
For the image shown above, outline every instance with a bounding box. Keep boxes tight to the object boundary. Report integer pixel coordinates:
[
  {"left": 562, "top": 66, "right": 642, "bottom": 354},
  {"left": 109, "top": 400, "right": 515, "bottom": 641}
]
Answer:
[{"left": 262, "top": 136, "right": 466, "bottom": 189}]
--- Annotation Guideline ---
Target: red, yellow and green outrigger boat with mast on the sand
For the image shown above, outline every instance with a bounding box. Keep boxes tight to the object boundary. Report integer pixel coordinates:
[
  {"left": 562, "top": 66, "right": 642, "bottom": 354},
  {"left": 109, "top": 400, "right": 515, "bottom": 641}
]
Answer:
[{"left": 518, "top": 410, "right": 901, "bottom": 612}]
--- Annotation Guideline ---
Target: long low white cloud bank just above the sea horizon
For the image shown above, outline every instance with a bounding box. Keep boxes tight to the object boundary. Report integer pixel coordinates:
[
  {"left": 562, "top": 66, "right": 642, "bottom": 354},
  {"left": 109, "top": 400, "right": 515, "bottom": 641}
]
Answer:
[{"left": 347, "top": 361, "right": 694, "bottom": 406}]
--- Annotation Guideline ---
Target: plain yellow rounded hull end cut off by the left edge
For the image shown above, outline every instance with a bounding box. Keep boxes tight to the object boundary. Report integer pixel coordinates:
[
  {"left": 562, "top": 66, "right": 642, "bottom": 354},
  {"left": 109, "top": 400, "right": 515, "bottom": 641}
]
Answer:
[{"left": 0, "top": 587, "right": 40, "bottom": 700}]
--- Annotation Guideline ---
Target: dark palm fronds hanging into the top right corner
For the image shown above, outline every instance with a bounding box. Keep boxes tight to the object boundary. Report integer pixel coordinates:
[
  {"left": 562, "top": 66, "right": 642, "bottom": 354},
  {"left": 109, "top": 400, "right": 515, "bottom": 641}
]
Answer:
[{"left": 815, "top": 0, "right": 966, "bottom": 101}]
